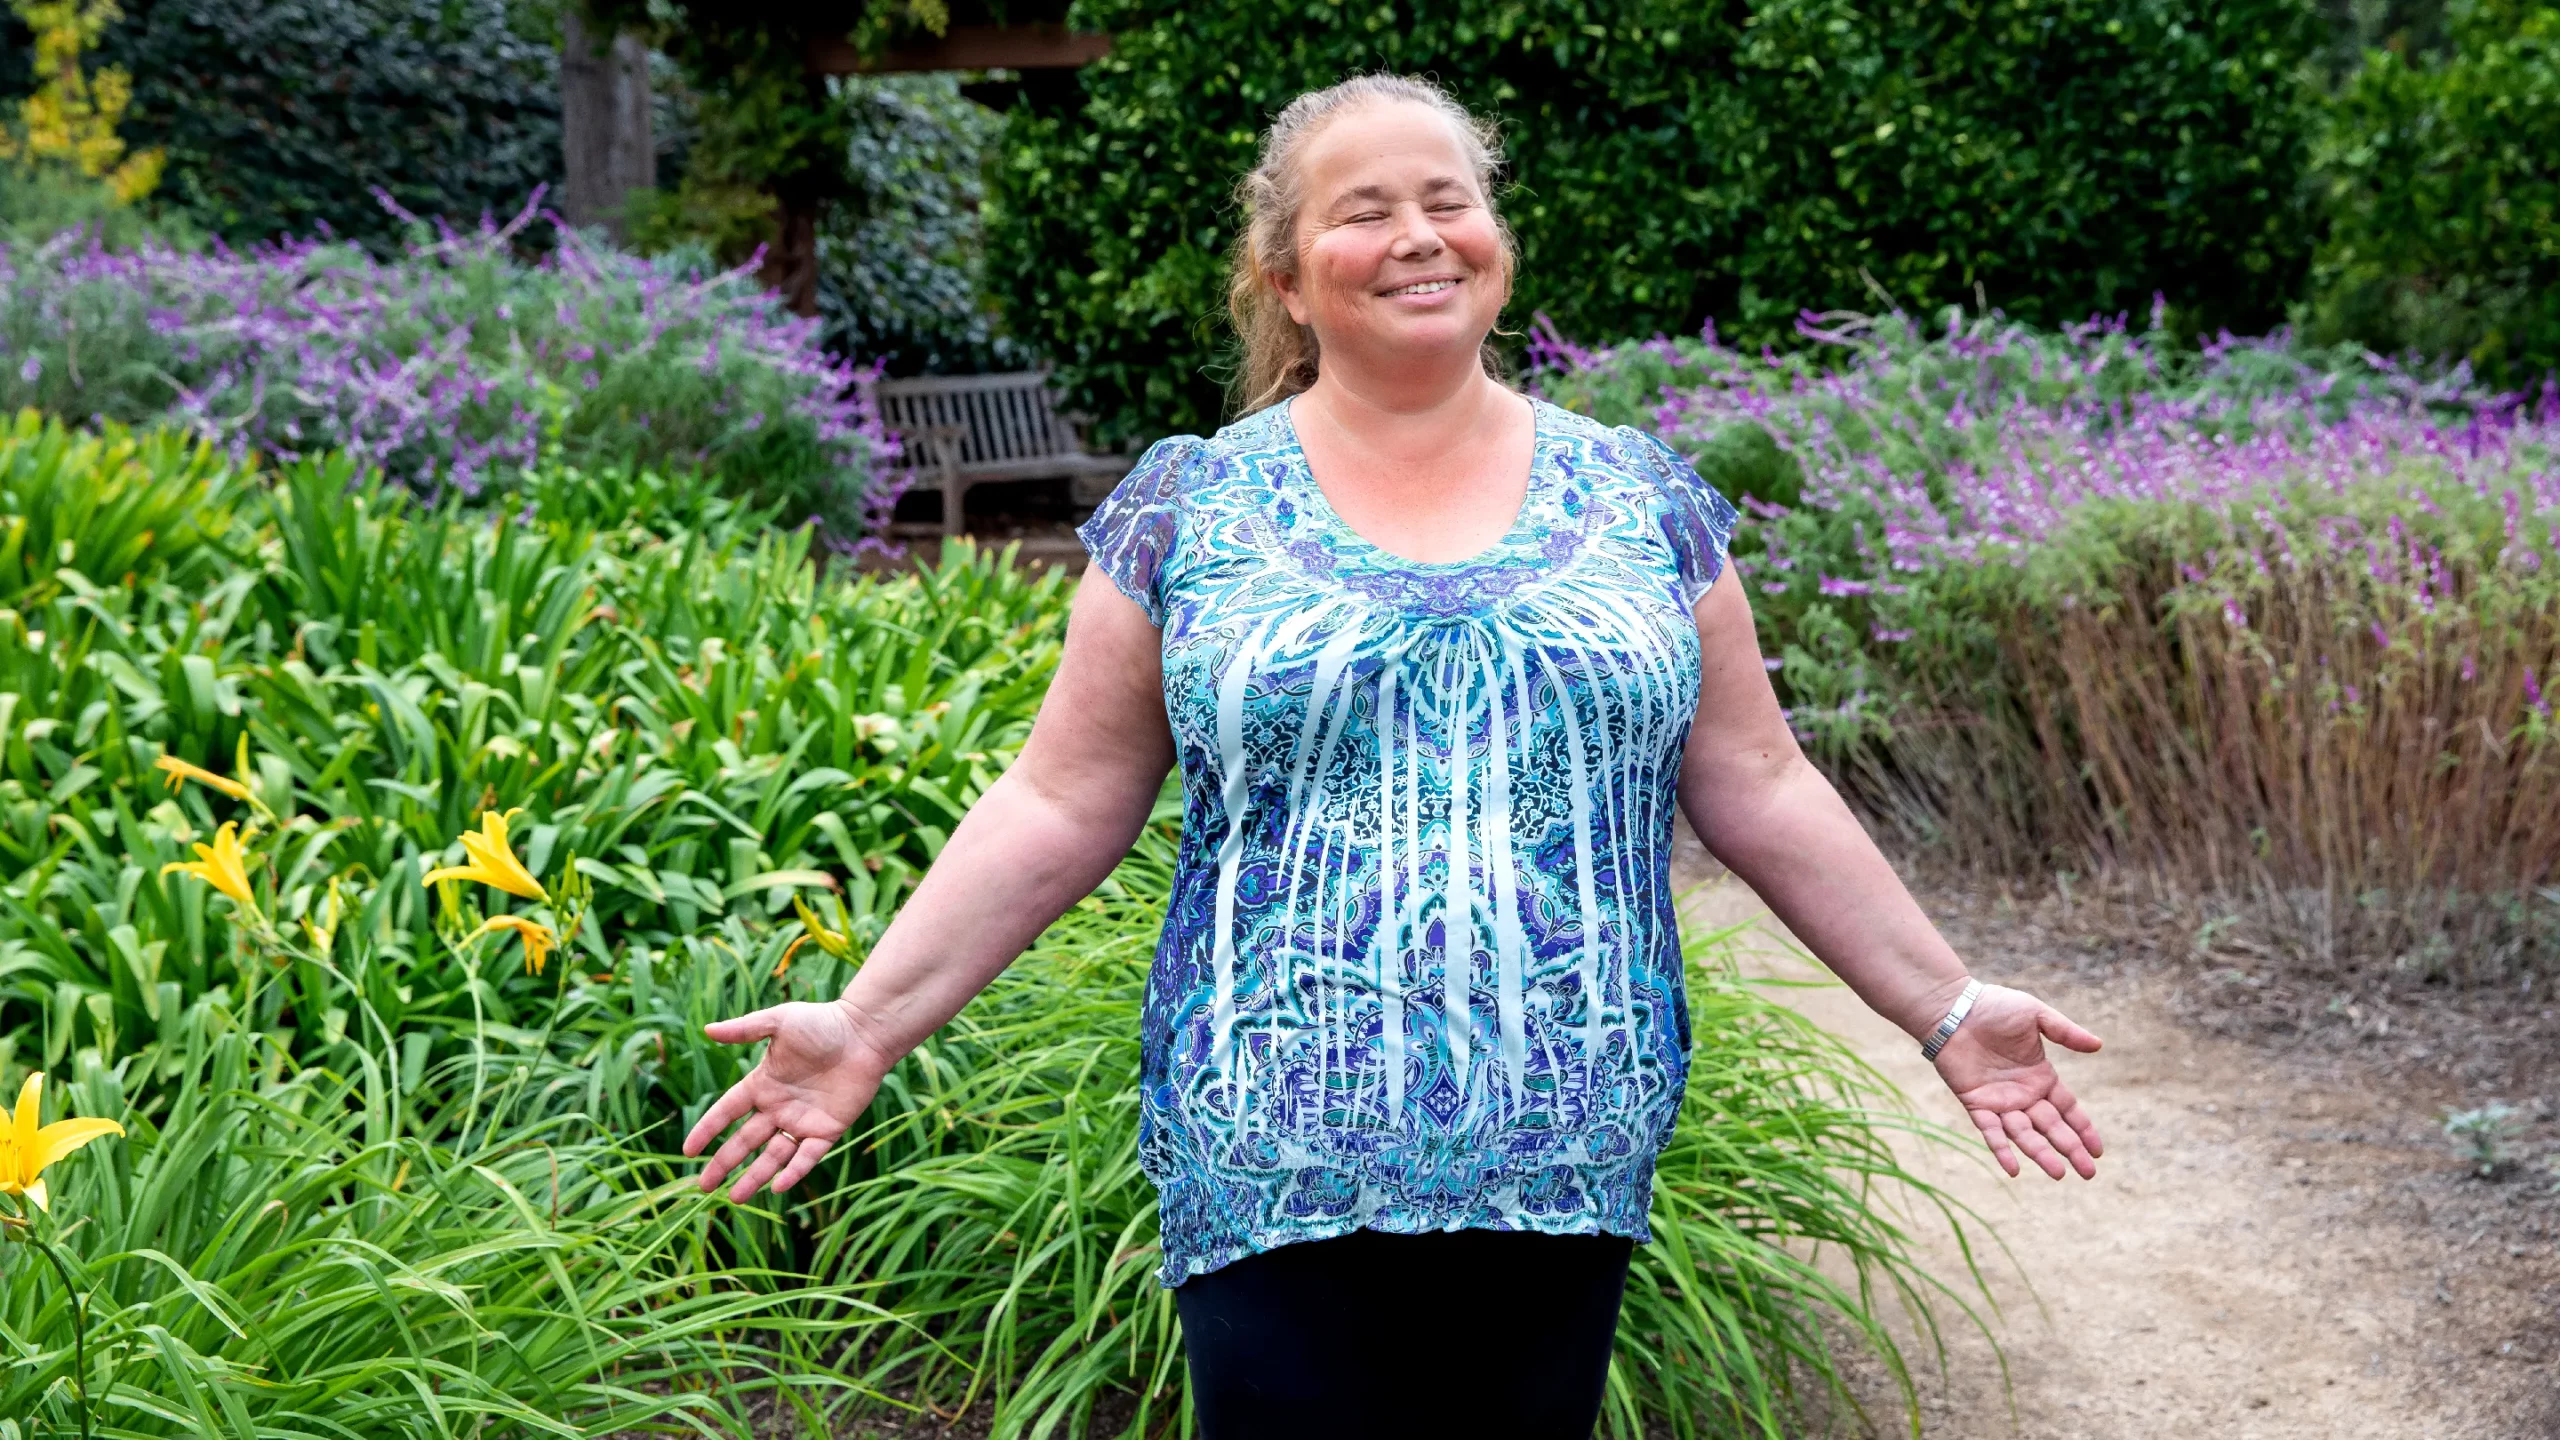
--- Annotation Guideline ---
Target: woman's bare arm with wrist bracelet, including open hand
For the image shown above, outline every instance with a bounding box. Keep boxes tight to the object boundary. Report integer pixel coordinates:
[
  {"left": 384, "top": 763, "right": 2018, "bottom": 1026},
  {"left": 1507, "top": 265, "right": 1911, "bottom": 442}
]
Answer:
[{"left": 1679, "top": 574, "right": 2102, "bottom": 1179}]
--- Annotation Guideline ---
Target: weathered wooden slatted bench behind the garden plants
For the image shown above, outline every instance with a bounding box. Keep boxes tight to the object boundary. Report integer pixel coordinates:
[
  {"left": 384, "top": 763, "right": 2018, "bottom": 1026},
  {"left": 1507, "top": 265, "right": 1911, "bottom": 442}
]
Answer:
[{"left": 878, "top": 372, "right": 1132, "bottom": 536}]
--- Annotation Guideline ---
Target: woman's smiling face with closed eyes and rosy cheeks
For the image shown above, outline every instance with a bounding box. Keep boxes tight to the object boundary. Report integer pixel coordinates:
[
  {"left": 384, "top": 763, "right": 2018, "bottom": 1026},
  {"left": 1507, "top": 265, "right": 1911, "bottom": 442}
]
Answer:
[{"left": 1272, "top": 100, "right": 1508, "bottom": 379}]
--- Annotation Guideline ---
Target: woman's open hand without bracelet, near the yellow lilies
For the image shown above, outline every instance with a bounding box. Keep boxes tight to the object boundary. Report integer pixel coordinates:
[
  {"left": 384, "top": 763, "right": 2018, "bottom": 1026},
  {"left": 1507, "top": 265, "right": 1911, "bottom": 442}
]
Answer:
[{"left": 684, "top": 999, "right": 888, "bottom": 1202}]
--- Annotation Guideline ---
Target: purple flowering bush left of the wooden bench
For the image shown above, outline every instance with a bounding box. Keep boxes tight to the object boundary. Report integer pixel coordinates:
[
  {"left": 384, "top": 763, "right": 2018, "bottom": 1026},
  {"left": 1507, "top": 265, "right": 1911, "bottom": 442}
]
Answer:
[{"left": 0, "top": 202, "right": 896, "bottom": 543}]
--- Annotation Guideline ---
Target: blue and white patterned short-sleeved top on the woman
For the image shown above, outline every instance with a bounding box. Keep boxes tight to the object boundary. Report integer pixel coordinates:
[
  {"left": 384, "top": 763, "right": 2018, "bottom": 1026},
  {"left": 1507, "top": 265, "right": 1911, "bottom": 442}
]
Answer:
[{"left": 1078, "top": 389, "right": 1736, "bottom": 1286}]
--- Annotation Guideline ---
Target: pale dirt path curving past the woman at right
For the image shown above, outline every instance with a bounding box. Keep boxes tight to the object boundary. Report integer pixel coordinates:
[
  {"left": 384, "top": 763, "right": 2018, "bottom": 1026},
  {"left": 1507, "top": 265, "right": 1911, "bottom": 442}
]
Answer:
[{"left": 1682, "top": 835, "right": 2560, "bottom": 1440}]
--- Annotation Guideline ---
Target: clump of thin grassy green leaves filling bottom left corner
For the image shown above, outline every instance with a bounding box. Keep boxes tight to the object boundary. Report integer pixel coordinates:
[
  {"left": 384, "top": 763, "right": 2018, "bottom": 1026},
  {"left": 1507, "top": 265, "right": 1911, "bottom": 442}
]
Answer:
[{"left": 0, "top": 1019, "right": 878, "bottom": 1440}]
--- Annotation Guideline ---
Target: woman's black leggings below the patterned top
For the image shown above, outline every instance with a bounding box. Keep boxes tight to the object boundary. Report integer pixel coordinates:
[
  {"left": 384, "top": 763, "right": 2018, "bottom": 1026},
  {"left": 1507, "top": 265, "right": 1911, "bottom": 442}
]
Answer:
[{"left": 1172, "top": 1230, "right": 1636, "bottom": 1440}]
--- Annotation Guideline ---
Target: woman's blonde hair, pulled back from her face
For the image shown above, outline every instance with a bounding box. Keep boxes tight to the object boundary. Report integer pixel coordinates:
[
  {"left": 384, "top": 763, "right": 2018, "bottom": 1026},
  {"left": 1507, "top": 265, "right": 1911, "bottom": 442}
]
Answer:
[{"left": 1226, "top": 74, "right": 1521, "bottom": 415}]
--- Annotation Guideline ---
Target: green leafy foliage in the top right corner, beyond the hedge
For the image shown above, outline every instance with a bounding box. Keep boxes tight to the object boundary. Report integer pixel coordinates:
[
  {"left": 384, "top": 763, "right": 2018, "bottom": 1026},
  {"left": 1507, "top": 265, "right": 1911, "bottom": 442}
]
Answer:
[{"left": 2309, "top": 0, "right": 2560, "bottom": 384}]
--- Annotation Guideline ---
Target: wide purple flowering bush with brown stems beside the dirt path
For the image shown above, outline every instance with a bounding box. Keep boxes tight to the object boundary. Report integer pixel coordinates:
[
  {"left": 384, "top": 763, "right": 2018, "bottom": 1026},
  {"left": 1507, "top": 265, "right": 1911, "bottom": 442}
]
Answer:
[{"left": 1533, "top": 313, "right": 2560, "bottom": 979}]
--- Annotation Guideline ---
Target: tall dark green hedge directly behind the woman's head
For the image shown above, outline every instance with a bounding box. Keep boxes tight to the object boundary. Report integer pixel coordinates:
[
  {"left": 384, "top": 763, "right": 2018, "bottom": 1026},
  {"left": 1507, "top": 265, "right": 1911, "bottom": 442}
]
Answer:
[{"left": 988, "top": 0, "right": 2317, "bottom": 438}]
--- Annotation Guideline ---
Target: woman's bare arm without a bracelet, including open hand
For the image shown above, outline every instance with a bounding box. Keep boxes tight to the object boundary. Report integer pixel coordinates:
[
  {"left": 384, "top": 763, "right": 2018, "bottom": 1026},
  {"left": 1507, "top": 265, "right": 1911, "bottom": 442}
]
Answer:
[{"left": 684, "top": 569, "right": 1172, "bottom": 1202}]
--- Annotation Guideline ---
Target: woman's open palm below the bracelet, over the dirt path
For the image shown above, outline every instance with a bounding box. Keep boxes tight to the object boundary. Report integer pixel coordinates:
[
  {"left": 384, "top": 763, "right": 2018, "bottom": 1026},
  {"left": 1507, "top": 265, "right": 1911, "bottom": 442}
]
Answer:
[{"left": 1938, "top": 984, "right": 2107, "bottom": 1181}]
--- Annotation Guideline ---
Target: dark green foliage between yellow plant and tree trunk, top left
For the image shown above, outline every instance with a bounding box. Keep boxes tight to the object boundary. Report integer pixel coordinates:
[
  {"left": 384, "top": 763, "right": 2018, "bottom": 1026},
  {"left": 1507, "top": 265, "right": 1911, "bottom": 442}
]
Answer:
[{"left": 0, "top": 0, "right": 561, "bottom": 254}]
